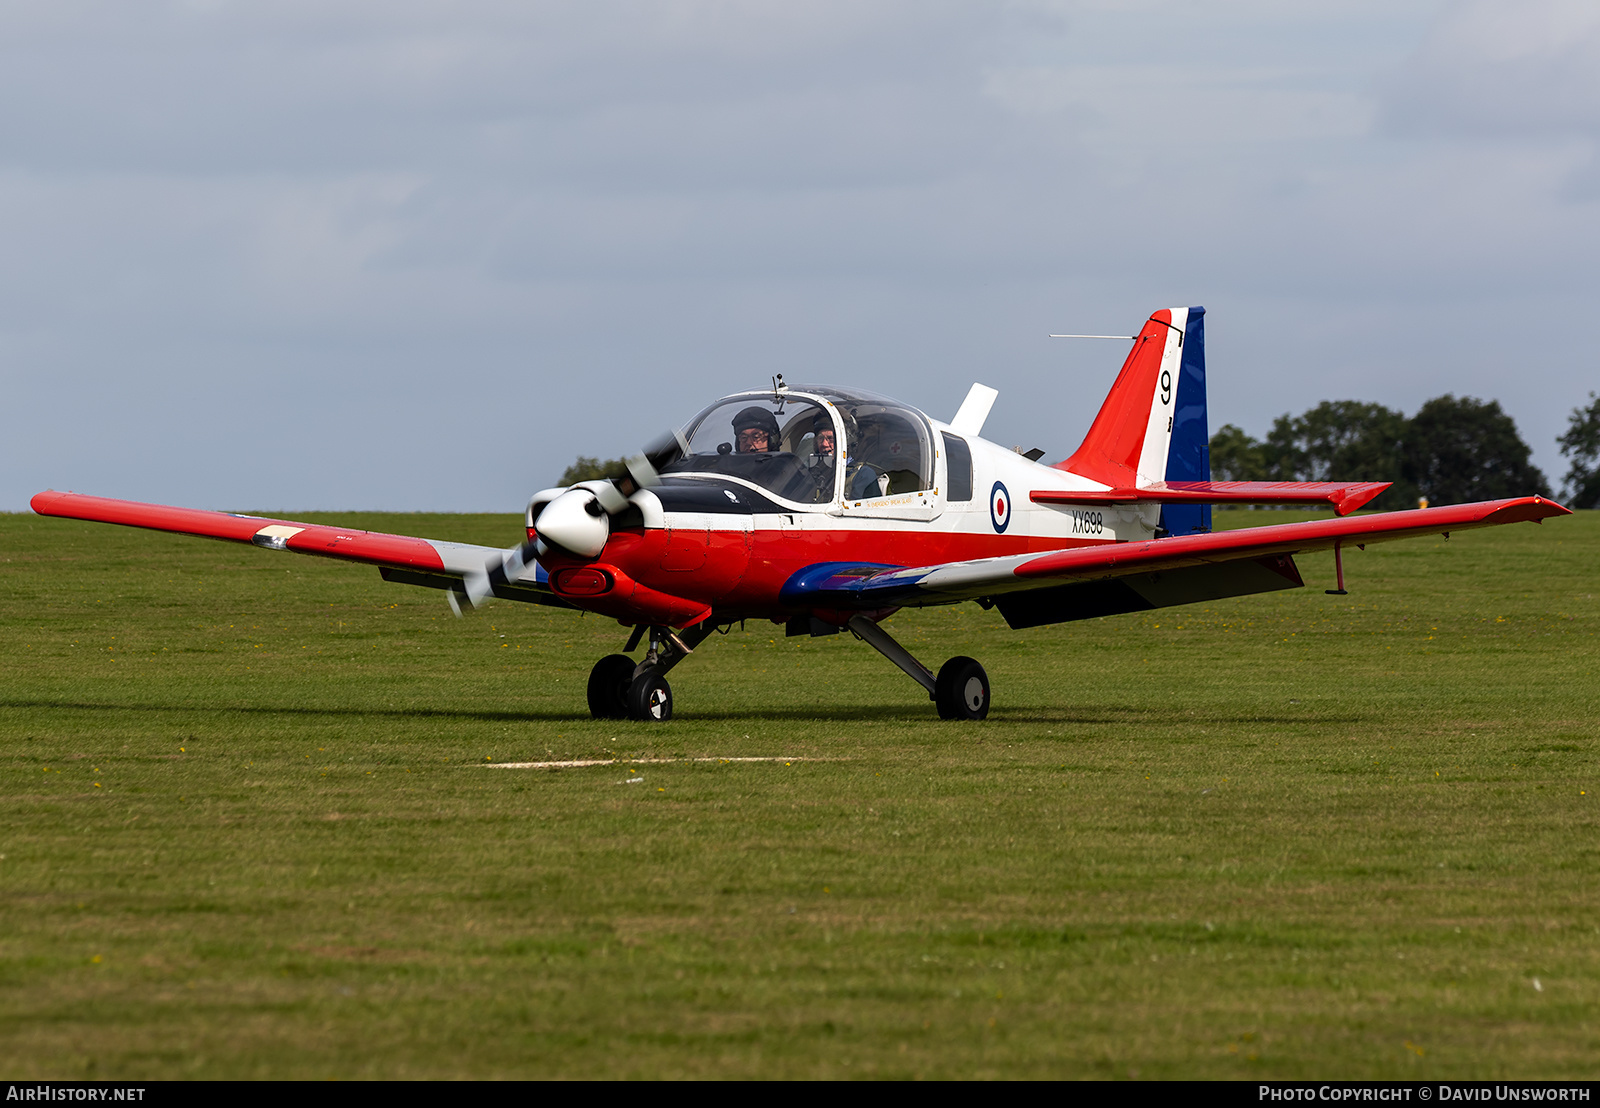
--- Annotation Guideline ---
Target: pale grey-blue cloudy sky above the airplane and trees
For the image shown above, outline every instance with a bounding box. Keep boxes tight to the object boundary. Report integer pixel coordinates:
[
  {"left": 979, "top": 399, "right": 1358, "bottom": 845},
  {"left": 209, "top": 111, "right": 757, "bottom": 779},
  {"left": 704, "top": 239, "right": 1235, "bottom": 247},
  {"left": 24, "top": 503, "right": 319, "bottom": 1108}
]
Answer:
[{"left": 0, "top": 0, "right": 1600, "bottom": 511}]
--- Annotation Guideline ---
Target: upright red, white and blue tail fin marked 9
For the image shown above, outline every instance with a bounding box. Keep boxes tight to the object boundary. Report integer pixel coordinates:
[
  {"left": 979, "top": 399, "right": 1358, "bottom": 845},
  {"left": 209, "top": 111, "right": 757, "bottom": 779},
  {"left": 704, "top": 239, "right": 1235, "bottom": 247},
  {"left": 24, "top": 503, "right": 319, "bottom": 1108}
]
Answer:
[{"left": 1056, "top": 307, "right": 1211, "bottom": 535}]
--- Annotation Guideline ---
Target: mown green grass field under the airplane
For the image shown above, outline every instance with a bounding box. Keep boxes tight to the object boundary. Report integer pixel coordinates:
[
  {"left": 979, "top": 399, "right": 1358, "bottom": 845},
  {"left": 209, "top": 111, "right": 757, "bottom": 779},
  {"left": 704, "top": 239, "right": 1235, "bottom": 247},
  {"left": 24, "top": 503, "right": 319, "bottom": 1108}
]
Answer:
[{"left": 0, "top": 512, "right": 1600, "bottom": 1079}]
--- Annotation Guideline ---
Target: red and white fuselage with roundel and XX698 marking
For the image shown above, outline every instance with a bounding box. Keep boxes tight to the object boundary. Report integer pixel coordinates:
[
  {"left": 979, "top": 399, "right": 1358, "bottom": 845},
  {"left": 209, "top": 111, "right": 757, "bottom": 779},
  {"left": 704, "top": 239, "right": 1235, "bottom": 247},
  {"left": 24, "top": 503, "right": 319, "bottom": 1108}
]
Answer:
[{"left": 528, "top": 387, "right": 1160, "bottom": 626}]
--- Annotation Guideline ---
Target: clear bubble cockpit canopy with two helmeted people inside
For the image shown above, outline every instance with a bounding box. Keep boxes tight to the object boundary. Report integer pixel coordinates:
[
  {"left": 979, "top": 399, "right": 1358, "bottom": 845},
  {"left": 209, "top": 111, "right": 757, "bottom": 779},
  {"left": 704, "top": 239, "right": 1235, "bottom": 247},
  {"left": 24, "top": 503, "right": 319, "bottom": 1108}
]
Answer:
[{"left": 661, "top": 386, "right": 934, "bottom": 504}]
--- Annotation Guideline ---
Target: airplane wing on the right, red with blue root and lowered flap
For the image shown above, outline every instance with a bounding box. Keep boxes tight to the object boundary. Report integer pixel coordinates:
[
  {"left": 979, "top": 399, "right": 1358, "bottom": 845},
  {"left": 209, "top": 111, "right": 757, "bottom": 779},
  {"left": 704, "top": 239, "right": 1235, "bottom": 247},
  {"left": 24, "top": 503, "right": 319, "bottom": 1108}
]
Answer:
[{"left": 782, "top": 496, "right": 1571, "bottom": 628}]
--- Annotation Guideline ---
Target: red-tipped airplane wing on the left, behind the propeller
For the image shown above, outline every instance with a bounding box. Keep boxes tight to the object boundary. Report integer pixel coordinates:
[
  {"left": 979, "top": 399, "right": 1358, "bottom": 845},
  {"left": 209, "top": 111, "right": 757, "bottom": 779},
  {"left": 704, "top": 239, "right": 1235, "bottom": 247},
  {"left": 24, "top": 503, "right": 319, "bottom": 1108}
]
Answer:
[{"left": 30, "top": 492, "right": 571, "bottom": 608}]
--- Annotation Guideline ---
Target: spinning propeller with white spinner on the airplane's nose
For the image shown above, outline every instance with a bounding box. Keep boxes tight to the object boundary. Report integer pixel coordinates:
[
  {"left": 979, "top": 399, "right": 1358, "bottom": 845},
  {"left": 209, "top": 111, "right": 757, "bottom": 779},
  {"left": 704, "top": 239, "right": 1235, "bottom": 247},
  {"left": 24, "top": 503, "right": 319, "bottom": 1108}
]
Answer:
[{"left": 446, "top": 431, "right": 690, "bottom": 616}]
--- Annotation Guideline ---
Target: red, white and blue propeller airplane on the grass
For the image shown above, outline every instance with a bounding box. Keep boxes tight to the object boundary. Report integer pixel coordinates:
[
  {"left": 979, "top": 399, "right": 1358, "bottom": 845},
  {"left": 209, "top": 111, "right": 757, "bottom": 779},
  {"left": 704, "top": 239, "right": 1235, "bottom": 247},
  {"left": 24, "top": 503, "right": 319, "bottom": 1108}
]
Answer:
[{"left": 32, "top": 307, "right": 1571, "bottom": 721}]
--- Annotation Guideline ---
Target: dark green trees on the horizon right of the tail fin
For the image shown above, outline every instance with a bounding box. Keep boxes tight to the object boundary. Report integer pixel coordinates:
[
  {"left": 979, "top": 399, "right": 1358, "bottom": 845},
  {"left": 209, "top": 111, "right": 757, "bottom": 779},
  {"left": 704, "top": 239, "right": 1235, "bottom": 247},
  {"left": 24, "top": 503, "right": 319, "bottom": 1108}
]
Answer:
[{"left": 1211, "top": 392, "right": 1600, "bottom": 511}]
